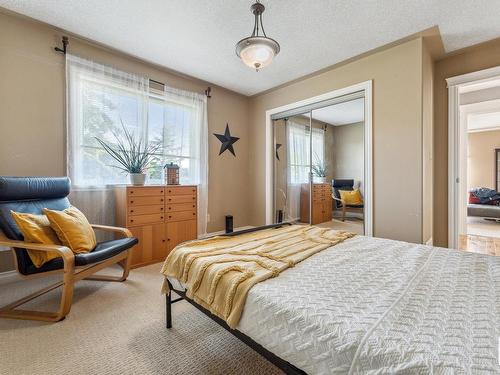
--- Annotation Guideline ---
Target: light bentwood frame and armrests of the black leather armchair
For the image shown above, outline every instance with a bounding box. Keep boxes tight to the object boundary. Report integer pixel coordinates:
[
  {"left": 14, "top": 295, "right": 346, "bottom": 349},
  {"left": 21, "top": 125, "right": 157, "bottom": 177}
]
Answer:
[{"left": 0, "top": 224, "right": 134, "bottom": 322}]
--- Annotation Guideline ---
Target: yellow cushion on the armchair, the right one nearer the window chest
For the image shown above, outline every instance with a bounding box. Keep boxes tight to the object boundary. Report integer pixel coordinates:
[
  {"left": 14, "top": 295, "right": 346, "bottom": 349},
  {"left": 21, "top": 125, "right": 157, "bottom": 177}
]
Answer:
[{"left": 43, "top": 206, "right": 97, "bottom": 254}]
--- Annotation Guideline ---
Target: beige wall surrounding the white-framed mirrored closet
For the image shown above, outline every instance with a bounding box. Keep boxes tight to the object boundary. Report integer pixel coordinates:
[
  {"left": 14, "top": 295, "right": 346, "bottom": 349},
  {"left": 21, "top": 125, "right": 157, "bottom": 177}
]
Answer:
[{"left": 249, "top": 38, "right": 422, "bottom": 242}]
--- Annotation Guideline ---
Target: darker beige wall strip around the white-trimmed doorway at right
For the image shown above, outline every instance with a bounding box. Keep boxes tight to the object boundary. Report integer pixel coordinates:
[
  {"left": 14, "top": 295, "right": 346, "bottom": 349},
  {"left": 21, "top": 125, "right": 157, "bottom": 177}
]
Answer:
[{"left": 433, "top": 39, "right": 500, "bottom": 246}]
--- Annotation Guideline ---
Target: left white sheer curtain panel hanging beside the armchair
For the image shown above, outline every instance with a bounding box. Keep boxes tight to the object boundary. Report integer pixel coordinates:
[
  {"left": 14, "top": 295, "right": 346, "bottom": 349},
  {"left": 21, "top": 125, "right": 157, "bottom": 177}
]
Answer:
[{"left": 66, "top": 53, "right": 149, "bottom": 234}]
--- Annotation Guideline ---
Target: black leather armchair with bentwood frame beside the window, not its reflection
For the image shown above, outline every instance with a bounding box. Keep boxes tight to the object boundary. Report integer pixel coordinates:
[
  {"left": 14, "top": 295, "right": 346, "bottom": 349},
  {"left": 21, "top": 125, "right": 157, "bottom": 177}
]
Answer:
[{"left": 0, "top": 177, "right": 138, "bottom": 321}]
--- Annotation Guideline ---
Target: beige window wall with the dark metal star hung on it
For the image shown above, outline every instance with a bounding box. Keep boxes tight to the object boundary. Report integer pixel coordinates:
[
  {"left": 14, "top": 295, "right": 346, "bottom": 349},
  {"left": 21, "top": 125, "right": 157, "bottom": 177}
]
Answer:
[{"left": 0, "top": 13, "right": 251, "bottom": 271}]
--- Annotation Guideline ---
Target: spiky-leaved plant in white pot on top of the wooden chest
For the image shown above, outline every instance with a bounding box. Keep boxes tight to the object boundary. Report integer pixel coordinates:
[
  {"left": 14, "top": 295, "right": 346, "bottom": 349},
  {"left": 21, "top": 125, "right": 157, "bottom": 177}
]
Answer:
[{"left": 95, "top": 123, "right": 161, "bottom": 185}]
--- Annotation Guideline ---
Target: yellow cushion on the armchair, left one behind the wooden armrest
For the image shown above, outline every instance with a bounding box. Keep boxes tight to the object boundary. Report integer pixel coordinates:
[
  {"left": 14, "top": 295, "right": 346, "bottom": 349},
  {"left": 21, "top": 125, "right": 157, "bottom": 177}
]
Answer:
[{"left": 10, "top": 211, "right": 61, "bottom": 268}]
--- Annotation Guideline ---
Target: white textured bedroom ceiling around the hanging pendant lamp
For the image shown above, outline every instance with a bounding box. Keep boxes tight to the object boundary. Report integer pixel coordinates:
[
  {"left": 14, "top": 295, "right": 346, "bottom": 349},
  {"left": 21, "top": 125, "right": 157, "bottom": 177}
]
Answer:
[{"left": 0, "top": 0, "right": 500, "bottom": 95}]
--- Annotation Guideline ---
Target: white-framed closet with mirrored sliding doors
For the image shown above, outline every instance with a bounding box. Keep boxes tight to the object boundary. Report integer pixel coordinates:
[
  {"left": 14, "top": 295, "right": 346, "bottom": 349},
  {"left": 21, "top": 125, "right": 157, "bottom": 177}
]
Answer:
[{"left": 266, "top": 81, "right": 372, "bottom": 235}]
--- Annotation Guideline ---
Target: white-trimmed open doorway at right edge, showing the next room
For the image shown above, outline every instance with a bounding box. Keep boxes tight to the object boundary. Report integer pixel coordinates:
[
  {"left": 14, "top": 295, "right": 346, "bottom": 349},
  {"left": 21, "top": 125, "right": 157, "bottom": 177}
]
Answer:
[{"left": 447, "top": 67, "right": 500, "bottom": 255}]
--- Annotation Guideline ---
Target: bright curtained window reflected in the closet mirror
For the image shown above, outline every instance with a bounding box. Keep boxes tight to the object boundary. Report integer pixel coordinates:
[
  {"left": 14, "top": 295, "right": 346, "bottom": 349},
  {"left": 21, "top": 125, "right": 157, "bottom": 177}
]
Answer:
[{"left": 287, "top": 120, "right": 325, "bottom": 184}]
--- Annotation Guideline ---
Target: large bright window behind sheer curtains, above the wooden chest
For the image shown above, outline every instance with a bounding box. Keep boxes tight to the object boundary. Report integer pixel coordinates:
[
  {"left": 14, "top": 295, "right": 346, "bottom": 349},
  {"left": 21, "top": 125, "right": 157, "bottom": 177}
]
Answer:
[{"left": 68, "top": 56, "right": 207, "bottom": 187}]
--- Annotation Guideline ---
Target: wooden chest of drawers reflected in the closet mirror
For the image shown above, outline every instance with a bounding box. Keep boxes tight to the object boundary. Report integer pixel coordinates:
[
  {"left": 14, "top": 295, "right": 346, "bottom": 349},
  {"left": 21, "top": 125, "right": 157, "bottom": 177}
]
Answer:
[{"left": 300, "top": 183, "right": 333, "bottom": 224}]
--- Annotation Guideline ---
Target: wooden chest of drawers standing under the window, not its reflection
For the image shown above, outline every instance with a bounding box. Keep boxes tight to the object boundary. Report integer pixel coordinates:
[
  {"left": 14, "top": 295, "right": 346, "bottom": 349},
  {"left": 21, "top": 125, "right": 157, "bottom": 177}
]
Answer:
[{"left": 115, "top": 185, "right": 198, "bottom": 267}]
